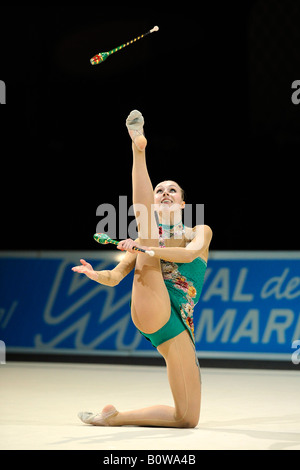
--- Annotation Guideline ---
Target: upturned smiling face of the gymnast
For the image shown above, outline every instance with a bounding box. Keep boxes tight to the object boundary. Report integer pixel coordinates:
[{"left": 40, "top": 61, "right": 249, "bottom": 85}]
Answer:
[{"left": 154, "top": 180, "right": 185, "bottom": 223}]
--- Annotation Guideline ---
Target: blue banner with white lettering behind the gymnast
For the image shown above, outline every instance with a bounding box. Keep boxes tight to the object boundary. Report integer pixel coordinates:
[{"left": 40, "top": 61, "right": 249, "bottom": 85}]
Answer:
[{"left": 0, "top": 251, "right": 300, "bottom": 360}]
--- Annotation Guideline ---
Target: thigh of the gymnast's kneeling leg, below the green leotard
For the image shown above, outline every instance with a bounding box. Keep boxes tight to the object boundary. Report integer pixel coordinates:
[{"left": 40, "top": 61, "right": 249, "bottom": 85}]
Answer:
[{"left": 157, "top": 331, "right": 201, "bottom": 427}]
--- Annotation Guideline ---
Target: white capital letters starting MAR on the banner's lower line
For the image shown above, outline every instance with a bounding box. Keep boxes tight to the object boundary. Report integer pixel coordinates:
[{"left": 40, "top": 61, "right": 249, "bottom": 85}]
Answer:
[{"left": 195, "top": 308, "right": 300, "bottom": 344}]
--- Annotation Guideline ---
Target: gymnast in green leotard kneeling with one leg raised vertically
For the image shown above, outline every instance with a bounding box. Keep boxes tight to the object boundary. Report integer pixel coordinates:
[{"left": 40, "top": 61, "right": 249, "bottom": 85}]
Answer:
[{"left": 72, "top": 111, "right": 212, "bottom": 428}]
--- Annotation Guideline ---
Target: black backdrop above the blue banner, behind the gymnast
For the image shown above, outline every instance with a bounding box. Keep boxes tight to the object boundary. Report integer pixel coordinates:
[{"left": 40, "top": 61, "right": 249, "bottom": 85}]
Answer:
[{"left": 0, "top": 0, "right": 300, "bottom": 368}]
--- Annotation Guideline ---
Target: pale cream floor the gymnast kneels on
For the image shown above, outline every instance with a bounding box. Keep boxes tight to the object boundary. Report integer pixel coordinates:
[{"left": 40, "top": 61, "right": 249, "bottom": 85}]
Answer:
[{"left": 0, "top": 362, "right": 300, "bottom": 451}]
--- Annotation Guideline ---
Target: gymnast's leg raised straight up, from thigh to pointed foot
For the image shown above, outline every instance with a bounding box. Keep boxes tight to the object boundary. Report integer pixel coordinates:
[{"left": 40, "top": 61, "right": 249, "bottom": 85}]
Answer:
[{"left": 127, "top": 111, "right": 171, "bottom": 333}]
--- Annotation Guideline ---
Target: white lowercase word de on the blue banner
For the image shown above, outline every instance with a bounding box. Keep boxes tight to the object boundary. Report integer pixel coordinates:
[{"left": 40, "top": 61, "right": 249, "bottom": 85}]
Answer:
[{"left": 261, "top": 268, "right": 300, "bottom": 300}]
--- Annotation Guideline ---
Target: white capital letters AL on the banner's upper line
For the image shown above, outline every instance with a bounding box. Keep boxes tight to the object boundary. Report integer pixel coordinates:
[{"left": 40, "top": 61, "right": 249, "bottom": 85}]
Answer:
[{"left": 202, "top": 268, "right": 254, "bottom": 302}]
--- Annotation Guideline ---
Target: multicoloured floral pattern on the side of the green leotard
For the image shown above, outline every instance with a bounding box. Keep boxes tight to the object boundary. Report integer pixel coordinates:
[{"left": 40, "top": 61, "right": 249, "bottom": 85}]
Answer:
[{"left": 161, "top": 261, "right": 197, "bottom": 336}]
